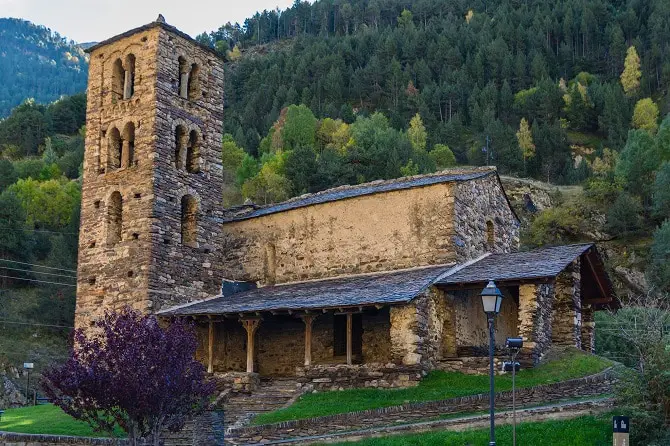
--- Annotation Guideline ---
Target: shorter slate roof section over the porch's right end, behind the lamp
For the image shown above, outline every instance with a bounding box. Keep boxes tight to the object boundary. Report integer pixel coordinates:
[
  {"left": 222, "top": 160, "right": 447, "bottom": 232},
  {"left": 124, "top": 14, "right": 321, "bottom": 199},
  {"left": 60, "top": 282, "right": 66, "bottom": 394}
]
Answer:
[{"left": 437, "top": 243, "right": 593, "bottom": 285}]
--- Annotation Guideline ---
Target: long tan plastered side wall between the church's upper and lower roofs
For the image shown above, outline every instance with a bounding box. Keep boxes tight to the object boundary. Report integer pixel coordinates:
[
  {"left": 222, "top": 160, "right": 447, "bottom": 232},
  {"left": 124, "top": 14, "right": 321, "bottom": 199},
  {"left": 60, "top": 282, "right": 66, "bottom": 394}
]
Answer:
[{"left": 222, "top": 184, "right": 456, "bottom": 284}]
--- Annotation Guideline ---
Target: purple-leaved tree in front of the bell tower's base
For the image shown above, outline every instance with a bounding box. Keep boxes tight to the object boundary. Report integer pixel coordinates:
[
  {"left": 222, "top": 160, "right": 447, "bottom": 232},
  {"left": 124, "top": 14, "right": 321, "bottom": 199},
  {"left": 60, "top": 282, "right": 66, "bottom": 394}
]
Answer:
[{"left": 42, "top": 307, "right": 214, "bottom": 446}]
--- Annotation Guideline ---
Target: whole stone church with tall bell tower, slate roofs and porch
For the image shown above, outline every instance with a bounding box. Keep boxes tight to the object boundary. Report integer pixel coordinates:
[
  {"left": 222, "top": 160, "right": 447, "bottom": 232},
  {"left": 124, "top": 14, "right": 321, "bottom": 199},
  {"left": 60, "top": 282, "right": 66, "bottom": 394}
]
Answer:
[{"left": 76, "top": 17, "right": 618, "bottom": 389}]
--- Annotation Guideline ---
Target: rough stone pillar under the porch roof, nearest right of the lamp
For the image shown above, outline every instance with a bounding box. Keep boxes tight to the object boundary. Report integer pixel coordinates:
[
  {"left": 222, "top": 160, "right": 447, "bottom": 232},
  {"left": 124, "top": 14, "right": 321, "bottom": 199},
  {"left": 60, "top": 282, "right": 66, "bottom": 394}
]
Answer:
[{"left": 518, "top": 284, "right": 554, "bottom": 365}]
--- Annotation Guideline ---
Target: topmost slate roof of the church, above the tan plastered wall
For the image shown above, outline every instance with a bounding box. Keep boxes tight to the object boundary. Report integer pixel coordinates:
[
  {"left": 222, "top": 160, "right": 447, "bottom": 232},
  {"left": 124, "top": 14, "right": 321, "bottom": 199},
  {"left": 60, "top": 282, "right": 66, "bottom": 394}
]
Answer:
[{"left": 223, "top": 168, "right": 496, "bottom": 222}]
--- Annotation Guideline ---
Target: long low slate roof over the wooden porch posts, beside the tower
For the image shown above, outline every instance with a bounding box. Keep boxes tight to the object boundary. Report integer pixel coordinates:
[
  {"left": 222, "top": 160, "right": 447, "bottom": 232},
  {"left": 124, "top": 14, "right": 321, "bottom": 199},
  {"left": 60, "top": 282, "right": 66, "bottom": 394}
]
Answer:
[{"left": 158, "top": 265, "right": 453, "bottom": 316}]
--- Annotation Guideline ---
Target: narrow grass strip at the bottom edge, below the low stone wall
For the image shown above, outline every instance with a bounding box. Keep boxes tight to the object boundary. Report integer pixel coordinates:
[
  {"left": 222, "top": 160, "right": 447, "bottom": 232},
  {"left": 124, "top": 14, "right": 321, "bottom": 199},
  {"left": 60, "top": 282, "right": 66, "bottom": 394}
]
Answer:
[{"left": 322, "top": 415, "right": 612, "bottom": 446}]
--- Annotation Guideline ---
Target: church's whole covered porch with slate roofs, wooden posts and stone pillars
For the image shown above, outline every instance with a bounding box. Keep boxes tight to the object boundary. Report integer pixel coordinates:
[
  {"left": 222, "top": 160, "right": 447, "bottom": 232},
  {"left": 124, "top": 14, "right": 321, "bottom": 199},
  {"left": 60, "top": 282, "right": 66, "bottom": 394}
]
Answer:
[{"left": 159, "top": 245, "right": 617, "bottom": 388}]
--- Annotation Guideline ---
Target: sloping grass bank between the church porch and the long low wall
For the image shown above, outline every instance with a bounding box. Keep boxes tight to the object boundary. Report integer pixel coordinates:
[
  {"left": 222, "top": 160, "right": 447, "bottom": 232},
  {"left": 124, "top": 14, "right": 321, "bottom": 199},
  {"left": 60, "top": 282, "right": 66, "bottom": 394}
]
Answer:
[{"left": 253, "top": 349, "right": 612, "bottom": 424}]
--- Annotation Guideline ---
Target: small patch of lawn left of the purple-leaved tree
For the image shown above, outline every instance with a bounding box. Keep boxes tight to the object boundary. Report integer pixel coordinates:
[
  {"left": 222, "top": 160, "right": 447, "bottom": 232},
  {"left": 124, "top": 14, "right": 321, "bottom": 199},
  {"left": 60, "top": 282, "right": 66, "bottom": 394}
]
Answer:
[{"left": 0, "top": 404, "right": 123, "bottom": 437}]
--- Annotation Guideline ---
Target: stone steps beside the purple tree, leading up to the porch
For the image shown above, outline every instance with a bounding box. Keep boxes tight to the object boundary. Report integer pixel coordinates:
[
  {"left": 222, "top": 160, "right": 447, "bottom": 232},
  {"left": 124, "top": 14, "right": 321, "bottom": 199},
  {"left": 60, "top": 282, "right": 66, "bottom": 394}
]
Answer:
[{"left": 223, "top": 378, "right": 302, "bottom": 430}]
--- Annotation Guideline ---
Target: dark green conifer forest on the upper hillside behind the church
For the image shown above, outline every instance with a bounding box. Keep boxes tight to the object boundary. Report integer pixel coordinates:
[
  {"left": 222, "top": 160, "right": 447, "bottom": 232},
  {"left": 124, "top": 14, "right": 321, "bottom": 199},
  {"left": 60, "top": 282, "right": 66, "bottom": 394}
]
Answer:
[{"left": 198, "top": 0, "right": 670, "bottom": 186}]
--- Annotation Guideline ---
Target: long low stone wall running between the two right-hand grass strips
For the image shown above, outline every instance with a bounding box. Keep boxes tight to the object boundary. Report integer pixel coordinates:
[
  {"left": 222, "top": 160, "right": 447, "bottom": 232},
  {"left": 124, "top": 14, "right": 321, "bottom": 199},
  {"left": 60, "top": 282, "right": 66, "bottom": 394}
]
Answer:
[{"left": 226, "top": 368, "right": 615, "bottom": 444}]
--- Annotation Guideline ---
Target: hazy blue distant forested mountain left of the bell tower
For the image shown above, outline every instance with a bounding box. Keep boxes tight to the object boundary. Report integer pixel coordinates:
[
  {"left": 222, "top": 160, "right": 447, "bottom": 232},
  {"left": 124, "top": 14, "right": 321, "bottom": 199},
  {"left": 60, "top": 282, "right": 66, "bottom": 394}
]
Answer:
[{"left": 0, "top": 18, "right": 88, "bottom": 118}]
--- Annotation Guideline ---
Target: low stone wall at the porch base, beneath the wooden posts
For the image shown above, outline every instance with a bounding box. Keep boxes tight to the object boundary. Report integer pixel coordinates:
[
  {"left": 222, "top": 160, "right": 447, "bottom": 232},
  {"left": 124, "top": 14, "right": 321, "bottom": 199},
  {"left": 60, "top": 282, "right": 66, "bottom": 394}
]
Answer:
[{"left": 296, "top": 364, "right": 426, "bottom": 390}]
